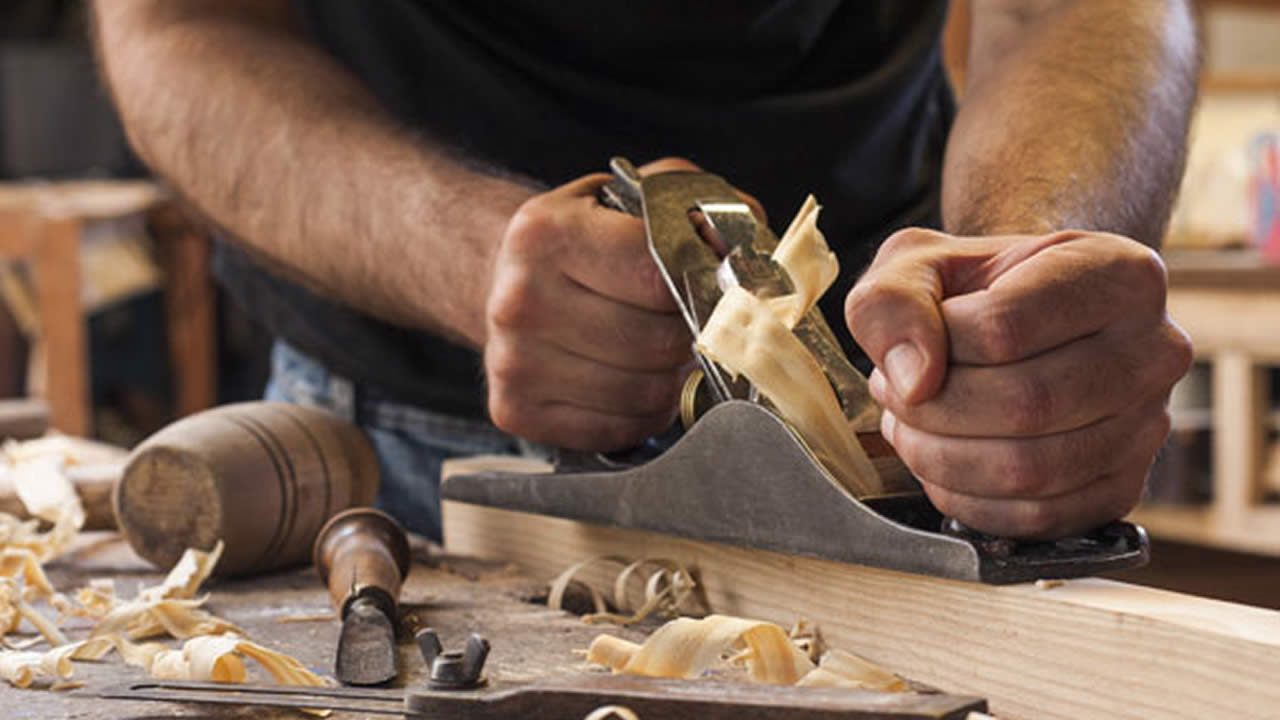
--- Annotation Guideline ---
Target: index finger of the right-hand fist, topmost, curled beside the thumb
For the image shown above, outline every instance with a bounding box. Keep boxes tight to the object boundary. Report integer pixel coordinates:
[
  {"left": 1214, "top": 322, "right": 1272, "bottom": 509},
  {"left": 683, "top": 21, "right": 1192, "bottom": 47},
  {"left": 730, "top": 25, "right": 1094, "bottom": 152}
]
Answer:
[{"left": 942, "top": 233, "right": 1166, "bottom": 365}]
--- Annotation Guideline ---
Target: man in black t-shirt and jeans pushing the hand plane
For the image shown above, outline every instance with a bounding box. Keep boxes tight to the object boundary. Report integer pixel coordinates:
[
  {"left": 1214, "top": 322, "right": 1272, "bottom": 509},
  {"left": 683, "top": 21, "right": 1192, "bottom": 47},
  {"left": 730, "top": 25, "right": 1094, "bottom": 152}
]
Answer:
[{"left": 96, "top": 0, "right": 1196, "bottom": 536}]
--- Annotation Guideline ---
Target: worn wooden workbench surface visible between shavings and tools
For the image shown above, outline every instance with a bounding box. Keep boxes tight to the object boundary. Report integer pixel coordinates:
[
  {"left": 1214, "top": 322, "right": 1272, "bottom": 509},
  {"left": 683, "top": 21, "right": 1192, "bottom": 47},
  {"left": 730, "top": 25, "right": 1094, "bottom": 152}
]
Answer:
[{"left": 12, "top": 533, "right": 645, "bottom": 720}]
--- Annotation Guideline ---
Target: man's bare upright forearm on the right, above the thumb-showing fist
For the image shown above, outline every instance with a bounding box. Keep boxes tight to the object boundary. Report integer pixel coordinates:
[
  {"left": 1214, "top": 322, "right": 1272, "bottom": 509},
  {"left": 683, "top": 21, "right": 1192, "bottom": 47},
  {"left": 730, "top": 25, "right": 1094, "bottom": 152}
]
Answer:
[{"left": 943, "top": 0, "right": 1197, "bottom": 247}]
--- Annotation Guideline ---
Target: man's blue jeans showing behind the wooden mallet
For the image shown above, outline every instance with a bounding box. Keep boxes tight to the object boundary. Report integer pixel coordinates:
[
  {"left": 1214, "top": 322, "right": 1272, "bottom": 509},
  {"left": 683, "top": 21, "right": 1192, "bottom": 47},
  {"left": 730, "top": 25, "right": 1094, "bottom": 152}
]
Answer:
[{"left": 266, "top": 340, "right": 531, "bottom": 541}]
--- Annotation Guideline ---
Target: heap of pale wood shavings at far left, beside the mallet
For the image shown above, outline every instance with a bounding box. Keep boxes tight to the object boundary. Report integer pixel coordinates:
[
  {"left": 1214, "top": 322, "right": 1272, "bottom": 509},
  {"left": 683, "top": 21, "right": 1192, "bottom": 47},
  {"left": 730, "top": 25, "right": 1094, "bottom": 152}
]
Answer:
[{"left": 0, "top": 437, "right": 328, "bottom": 688}]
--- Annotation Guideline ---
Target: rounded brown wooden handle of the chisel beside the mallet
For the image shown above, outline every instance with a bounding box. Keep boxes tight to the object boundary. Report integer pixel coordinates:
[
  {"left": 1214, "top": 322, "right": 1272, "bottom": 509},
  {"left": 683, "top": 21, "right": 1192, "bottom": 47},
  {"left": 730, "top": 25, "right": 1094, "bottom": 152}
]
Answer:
[{"left": 314, "top": 507, "right": 410, "bottom": 620}]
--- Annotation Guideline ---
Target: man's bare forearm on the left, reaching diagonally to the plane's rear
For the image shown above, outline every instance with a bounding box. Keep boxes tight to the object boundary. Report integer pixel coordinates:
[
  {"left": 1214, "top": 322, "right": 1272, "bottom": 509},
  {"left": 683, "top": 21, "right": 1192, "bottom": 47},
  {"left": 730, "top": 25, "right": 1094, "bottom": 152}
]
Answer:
[{"left": 96, "top": 0, "right": 530, "bottom": 346}]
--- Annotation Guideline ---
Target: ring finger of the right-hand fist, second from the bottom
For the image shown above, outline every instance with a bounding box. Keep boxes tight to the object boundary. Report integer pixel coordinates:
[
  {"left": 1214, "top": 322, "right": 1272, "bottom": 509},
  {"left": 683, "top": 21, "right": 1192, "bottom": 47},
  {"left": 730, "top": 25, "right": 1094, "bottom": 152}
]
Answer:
[{"left": 881, "top": 402, "right": 1169, "bottom": 500}]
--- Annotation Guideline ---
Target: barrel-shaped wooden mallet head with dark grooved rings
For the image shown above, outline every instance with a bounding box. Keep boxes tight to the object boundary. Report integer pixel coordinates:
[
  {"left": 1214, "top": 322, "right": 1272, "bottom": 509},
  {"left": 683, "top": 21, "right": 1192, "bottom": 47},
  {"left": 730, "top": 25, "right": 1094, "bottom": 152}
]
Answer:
[{"left": 113, "top": 402, "right": 379, "bottom": 575}]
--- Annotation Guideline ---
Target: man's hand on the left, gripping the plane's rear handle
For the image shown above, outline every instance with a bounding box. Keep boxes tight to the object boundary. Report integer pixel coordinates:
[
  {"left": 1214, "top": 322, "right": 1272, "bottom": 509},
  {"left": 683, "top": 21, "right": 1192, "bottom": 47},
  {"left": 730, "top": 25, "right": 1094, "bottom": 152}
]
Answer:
[{"left": 484, "top": 167, "right": 695, "bottom": 451}]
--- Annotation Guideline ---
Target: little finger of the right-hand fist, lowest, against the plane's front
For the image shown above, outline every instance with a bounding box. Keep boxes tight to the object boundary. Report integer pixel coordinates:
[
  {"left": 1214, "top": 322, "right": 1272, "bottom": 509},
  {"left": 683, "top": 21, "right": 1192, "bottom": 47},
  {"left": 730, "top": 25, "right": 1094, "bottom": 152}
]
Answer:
[{"left": 923, "top": 459, "right": 1151, "bottom": 538}]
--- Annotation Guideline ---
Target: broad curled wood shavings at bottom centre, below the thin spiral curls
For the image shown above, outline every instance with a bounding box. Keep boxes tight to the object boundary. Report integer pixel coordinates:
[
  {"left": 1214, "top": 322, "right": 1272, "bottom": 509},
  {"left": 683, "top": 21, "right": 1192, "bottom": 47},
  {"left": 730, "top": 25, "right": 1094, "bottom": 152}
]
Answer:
[{"left": 586, "top": 615, "right": 909, "bottom": 692}]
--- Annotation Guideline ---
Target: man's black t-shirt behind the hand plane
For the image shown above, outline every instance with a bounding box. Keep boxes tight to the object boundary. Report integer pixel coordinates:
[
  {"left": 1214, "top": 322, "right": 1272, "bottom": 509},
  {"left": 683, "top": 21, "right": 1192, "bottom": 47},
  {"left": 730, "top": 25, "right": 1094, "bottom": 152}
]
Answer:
[{"left": 218, "top": 0, "right": 954, "bottom": 416}]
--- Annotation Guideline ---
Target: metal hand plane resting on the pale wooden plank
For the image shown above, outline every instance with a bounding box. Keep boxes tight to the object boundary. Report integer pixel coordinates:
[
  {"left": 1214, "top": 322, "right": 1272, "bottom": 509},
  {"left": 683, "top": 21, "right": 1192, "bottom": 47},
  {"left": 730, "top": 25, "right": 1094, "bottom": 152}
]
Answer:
[{"left": 440, "top": 158, "right": 1149, "bottom": 583}]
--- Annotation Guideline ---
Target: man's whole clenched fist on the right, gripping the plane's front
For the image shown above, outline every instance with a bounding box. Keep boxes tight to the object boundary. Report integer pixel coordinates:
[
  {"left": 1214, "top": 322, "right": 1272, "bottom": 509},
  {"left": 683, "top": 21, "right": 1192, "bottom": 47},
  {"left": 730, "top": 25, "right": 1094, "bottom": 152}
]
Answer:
[{"left": 845, "top": 228, "right": 1192, "bottom": 537}]
